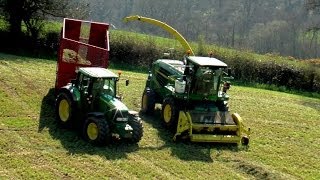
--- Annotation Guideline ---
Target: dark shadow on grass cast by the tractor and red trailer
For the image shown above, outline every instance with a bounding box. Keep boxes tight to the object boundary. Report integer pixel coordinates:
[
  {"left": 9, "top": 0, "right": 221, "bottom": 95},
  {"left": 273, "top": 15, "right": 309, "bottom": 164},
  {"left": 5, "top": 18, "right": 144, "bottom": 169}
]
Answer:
[{"left": 38, "top": 88, "right": 139, "bottom": 160}]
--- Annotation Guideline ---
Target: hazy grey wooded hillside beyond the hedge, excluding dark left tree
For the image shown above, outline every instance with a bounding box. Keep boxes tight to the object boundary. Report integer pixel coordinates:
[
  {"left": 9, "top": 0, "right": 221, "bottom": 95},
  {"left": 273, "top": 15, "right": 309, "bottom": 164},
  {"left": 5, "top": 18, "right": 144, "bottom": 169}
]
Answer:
[{"left": 89, "top": 0, "right": 320, "bottom": 58}]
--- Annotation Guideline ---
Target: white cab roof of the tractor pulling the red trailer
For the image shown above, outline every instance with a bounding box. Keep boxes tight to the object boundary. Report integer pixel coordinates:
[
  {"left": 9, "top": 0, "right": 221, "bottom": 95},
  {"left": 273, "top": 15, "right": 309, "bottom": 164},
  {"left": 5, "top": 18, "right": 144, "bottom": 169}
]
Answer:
[{"left": 79, "top": 67, "right": 118, "bottom": 78}]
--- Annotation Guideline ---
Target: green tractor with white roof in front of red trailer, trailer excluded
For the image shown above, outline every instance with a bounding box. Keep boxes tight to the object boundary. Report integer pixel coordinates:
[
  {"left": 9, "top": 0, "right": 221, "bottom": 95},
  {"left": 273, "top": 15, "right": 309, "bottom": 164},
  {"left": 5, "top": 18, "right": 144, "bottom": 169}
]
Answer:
[{"left": 56, "top": 67, "right": 143, "bottom": 145}]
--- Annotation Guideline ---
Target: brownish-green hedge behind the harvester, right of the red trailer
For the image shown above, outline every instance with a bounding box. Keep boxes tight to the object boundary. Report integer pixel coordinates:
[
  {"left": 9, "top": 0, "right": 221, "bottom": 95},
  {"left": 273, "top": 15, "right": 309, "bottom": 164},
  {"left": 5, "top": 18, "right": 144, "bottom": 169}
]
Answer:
[{"left": 110, "top": 32, "right": 320, "bottom": 92}]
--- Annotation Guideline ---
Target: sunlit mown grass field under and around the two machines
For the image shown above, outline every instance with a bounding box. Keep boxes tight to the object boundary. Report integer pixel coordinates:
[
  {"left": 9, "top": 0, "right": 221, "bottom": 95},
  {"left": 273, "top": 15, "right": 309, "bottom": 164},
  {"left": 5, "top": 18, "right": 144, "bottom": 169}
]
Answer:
[{"left": 0, "top": 53, "right": 320, "bottom": 179}]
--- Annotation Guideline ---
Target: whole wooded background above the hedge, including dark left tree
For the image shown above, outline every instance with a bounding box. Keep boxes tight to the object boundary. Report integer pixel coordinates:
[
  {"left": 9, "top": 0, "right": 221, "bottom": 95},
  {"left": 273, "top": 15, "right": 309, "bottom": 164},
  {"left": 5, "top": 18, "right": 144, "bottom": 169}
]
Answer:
[{"left": 0, "top": 0, "right": 320, "bottom": 59}]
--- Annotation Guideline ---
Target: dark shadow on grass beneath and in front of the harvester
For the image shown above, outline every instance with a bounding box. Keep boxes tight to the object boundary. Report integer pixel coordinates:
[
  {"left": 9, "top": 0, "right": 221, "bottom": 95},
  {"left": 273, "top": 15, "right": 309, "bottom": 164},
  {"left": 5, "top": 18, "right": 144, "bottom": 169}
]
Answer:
[{"left": 140, "top": 109, "right": 241, "bottom": 162}]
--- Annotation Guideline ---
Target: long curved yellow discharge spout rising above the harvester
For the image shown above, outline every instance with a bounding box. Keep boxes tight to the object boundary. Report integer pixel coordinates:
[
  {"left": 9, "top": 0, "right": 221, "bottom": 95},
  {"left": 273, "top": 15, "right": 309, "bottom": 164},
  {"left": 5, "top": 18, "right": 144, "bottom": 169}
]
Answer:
[{"left": 124, "top": 15, "right": 194, "bottom": 56}]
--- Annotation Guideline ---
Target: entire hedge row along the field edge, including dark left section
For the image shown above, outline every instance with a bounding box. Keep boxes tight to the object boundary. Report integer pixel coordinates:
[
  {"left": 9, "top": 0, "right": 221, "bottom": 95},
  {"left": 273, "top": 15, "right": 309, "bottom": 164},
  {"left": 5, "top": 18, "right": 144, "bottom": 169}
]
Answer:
[{"left": 0, "top": 29, "right": 320, "bottom": 93}]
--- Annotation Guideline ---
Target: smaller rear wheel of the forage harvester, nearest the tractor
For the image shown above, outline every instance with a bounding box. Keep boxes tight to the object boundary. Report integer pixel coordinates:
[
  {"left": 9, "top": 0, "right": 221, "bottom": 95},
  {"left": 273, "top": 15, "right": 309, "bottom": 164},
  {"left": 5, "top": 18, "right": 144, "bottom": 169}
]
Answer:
[{"left": 141, "top": 89, "right": 155, "bottom": 114}]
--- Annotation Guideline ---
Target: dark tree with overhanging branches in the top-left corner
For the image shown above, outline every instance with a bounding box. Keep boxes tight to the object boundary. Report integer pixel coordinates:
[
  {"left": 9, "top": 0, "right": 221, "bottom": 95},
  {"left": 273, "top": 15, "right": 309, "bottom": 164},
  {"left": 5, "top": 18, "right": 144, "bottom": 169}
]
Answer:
[{"left": 0, "top": 0, "right": 89, "bottom": 38}]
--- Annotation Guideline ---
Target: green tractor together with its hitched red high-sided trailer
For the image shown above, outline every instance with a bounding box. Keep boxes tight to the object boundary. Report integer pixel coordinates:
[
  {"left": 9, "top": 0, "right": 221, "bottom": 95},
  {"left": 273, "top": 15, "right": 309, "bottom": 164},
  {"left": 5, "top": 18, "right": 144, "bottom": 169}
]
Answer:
[{"left": 55, "top": 19, "right": 143, "bottom": 145}]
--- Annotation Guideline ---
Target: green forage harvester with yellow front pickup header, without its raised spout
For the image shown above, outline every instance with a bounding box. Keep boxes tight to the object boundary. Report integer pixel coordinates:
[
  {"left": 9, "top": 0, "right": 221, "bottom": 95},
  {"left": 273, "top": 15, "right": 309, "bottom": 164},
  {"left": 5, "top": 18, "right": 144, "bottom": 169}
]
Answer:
[{"left": 141, "top": 56, "right": 250, "bottom": 145}]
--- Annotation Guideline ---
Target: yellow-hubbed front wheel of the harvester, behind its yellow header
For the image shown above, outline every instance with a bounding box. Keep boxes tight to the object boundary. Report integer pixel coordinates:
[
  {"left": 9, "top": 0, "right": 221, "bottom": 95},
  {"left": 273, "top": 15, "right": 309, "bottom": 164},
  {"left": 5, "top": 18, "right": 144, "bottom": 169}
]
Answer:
[{"left": 161, "top": 98, "right": 179, "bottom": 131}]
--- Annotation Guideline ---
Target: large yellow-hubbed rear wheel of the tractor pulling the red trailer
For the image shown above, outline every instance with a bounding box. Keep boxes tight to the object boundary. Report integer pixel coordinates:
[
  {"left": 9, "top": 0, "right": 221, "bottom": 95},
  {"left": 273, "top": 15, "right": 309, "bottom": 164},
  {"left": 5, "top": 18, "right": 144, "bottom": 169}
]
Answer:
[{"left": 55, "top": 92, "right": 76, "bottom": 128}]
